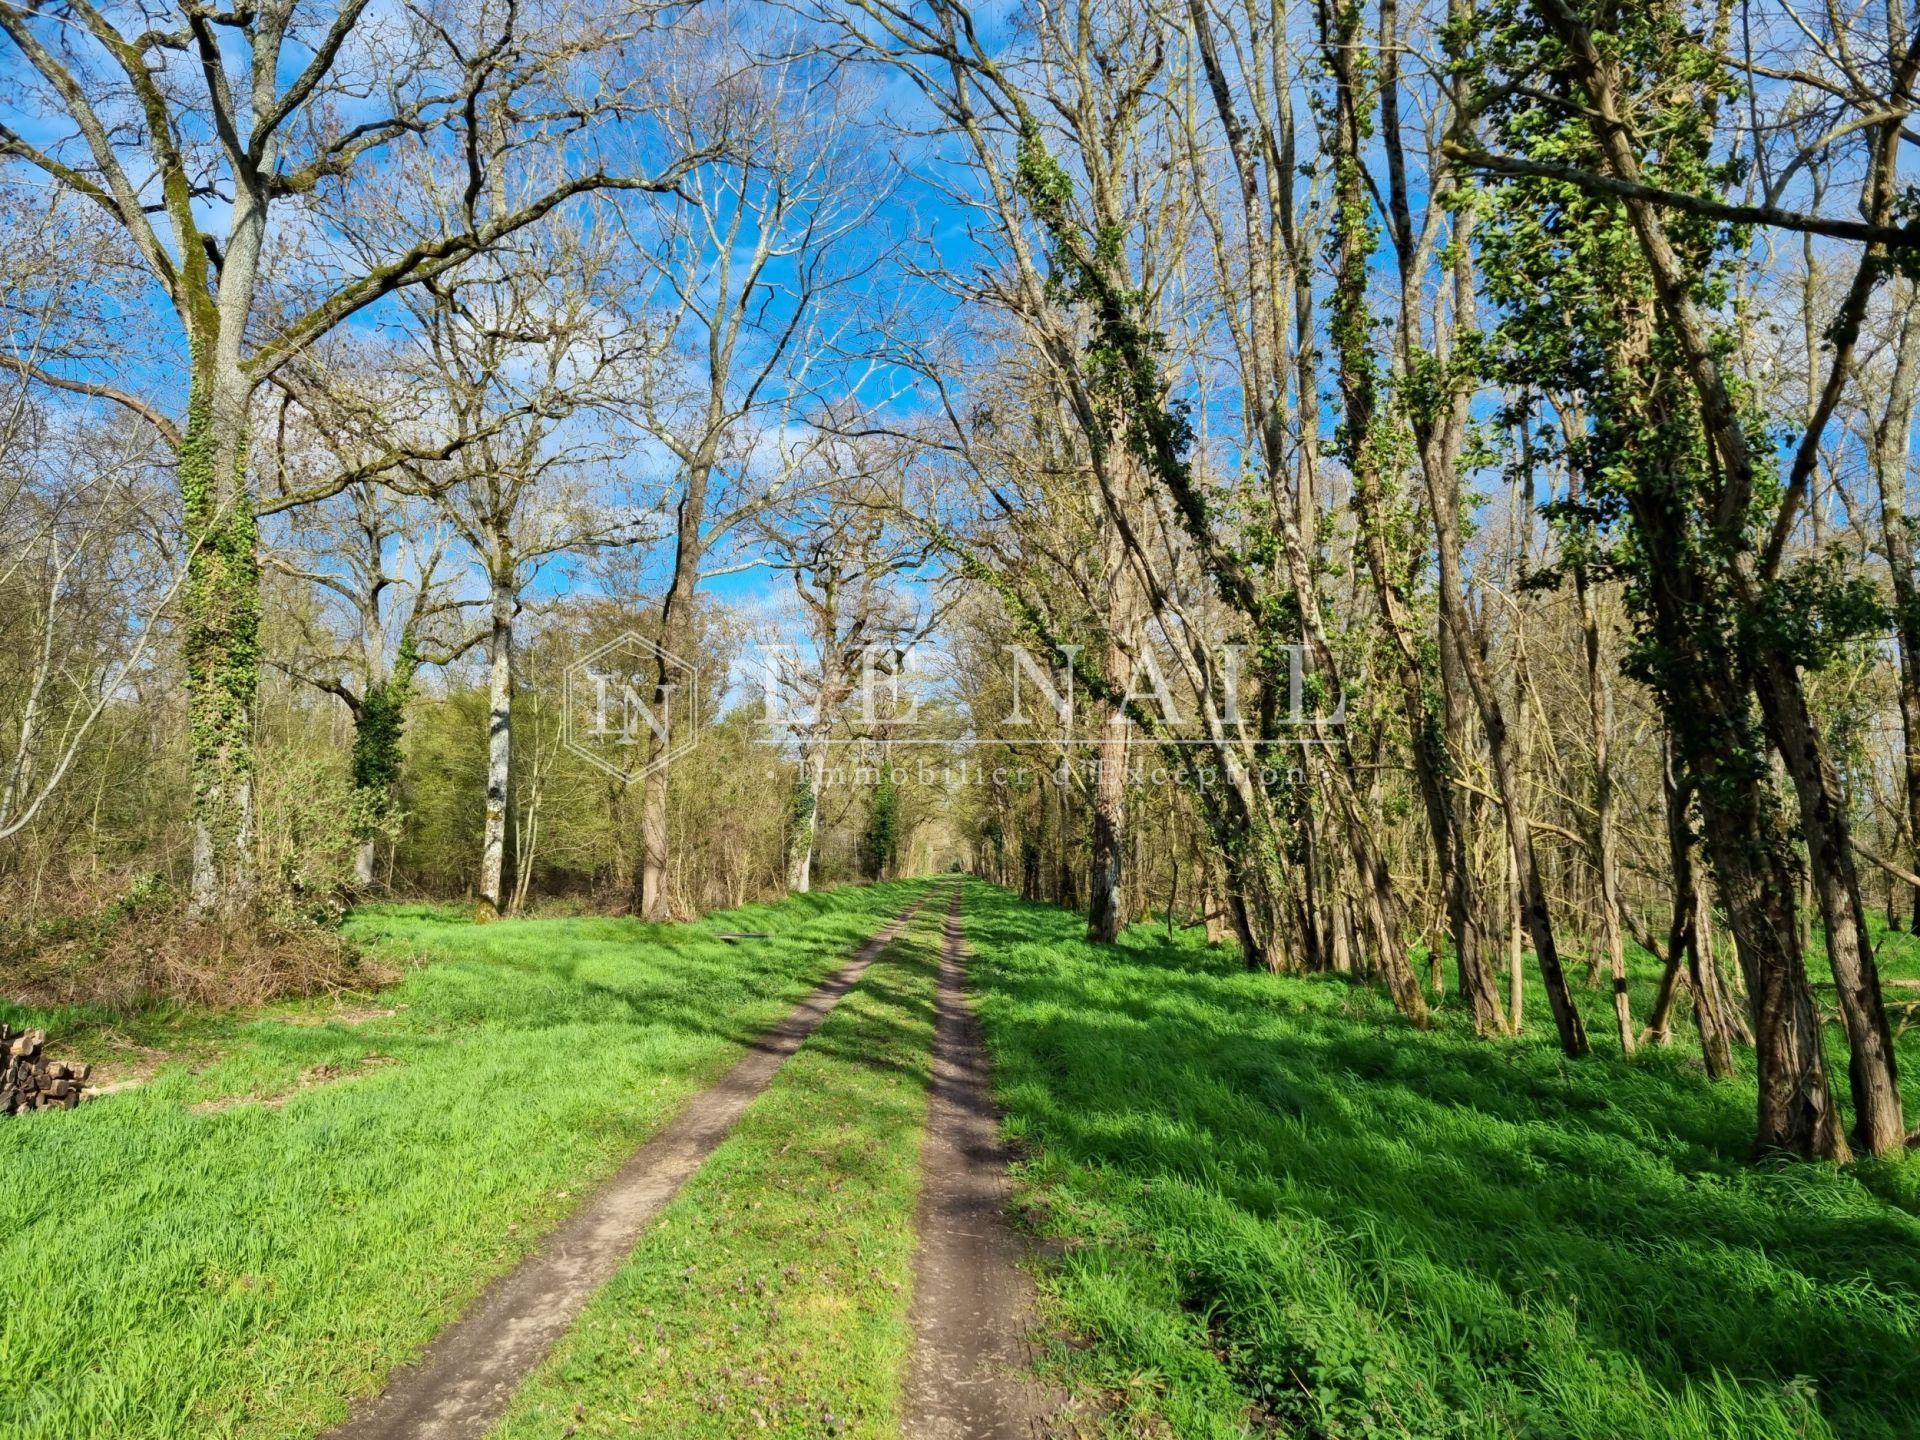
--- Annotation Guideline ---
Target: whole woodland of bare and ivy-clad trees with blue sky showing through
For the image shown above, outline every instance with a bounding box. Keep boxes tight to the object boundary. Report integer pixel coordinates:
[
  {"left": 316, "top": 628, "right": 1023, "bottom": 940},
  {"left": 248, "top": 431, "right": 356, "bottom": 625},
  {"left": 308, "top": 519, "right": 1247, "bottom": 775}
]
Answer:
[{"left": 11, "top": 0, "right": 1920, "bottom": 1162}]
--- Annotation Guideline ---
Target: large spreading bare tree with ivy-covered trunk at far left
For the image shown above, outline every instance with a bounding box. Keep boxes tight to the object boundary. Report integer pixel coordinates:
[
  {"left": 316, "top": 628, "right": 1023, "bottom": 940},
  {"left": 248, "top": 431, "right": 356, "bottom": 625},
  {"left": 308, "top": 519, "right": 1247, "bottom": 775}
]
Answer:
[{"left": 0, "top": 0, "right": 699, "bottom": 910}]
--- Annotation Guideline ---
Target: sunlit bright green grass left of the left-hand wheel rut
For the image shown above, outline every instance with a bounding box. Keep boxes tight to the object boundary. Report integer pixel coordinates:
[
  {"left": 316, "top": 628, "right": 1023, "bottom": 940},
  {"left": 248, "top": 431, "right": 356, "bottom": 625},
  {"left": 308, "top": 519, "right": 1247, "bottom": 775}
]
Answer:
[{"left": 0, "top": 883, "right": 920, "bottom": 1440}]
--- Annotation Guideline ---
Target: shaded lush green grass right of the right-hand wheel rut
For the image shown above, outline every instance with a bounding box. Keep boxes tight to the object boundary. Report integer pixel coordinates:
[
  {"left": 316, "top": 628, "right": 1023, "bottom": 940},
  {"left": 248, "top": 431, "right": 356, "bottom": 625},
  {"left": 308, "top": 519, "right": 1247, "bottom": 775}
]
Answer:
[{"left": 968, "top": 885, "right": 1920, "bottom": 1440}]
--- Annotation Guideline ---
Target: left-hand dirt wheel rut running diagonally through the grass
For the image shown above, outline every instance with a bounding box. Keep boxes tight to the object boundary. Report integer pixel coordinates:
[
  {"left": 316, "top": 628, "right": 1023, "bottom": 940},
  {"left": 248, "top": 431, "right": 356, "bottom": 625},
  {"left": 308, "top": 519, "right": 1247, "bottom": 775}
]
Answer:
[{"left": 324, "top": 891, "right": 927, "bottom": 1440}]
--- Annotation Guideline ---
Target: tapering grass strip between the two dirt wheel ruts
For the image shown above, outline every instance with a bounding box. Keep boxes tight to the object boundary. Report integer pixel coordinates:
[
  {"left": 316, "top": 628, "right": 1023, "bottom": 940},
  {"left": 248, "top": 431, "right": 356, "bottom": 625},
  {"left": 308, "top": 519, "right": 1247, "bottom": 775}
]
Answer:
[{"left": 493, "top": 889, "right": 945, "bottom": 1440}]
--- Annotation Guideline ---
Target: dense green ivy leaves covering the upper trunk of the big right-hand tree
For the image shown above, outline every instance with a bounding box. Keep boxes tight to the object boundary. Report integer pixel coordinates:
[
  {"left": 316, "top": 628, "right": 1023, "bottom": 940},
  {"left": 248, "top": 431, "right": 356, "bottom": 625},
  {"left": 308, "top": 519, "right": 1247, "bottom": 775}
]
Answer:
[{"left": 1450, "top": 0, "right": 1858, "bottom": 808}]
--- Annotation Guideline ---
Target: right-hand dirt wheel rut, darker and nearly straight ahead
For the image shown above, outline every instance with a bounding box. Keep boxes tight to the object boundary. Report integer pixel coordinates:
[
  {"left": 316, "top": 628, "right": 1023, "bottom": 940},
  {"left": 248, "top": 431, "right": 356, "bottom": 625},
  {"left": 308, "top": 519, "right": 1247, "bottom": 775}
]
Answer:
[{"left": 900, "top": 889, "right": 1077, "bottom": 1440}]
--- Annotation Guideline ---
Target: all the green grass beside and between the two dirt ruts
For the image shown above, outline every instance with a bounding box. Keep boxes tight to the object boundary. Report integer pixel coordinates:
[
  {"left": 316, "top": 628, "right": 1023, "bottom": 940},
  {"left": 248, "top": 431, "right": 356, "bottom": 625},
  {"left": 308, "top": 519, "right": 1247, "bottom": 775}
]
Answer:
[{"left": 0, "top": 883, "right": 1920, "bottom": 1440}]
